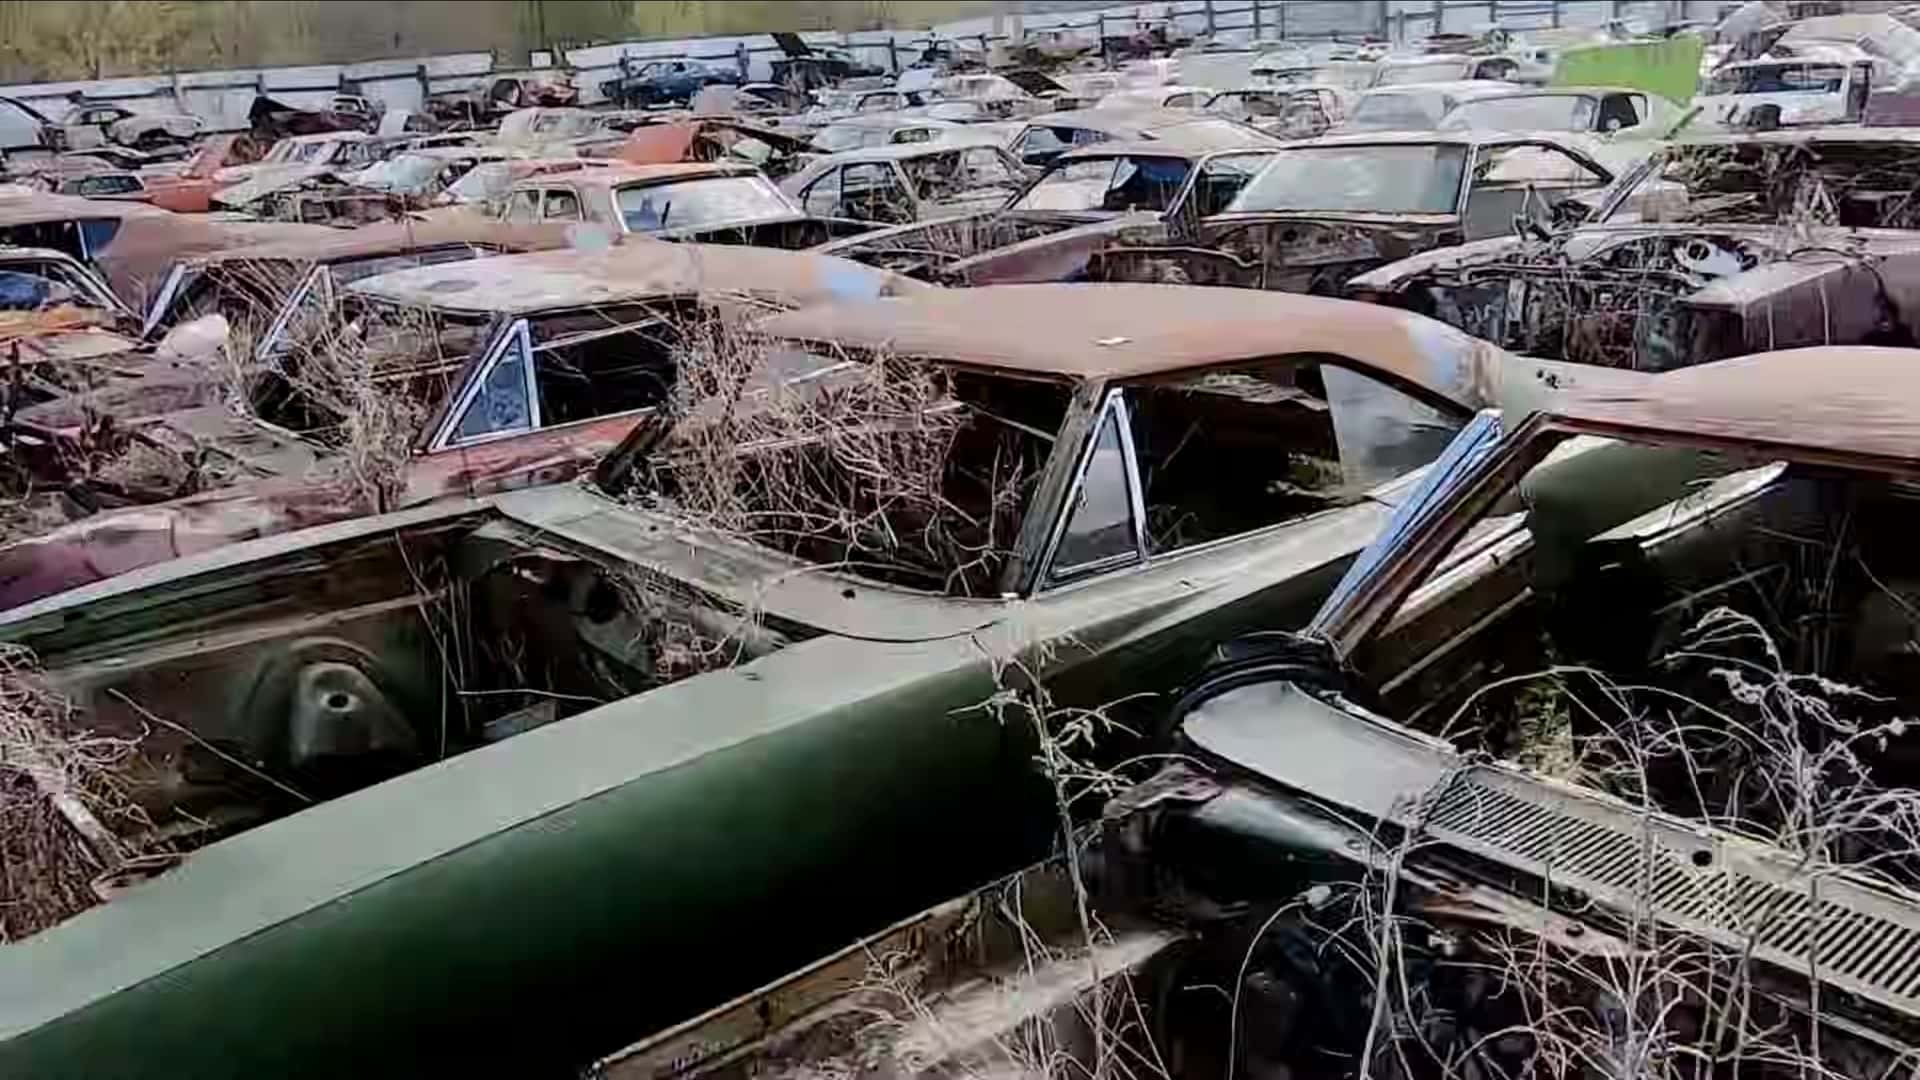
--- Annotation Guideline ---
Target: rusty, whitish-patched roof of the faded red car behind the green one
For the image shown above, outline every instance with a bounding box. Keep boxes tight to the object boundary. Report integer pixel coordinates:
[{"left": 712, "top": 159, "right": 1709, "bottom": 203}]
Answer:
[{"left": 349, "top": 238, "right": 935, "bottom": 315}]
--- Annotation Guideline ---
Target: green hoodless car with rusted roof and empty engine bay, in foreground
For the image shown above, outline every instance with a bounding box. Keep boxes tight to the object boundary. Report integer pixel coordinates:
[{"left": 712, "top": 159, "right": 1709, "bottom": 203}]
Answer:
[{"left": 0, "top": 278, "right": 1566, "bottom": 1076}]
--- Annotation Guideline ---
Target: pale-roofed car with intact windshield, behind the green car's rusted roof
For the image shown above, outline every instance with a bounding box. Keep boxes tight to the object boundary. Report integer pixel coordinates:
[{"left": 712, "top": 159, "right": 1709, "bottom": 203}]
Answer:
[{"left": 1091, "top": 133, "right": 1613, "bottom": 296}]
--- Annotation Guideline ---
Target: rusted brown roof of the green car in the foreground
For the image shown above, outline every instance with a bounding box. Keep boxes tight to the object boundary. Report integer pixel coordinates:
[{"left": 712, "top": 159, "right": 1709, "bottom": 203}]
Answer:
[{"left": 762, "top": 284, "right": 1498, "bottom": 392}]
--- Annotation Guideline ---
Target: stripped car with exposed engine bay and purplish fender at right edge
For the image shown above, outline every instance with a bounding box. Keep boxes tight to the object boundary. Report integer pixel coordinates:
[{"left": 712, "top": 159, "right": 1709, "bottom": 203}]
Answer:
[{"left": 1346, "top": 129, "right": 1920, "bottom": 371}]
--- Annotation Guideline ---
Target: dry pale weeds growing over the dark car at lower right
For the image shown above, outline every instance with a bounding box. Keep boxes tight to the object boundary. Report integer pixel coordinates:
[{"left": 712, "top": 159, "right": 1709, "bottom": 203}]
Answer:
[{"left": 1321, "top": 607, "right": 1920, "bottom": 1080}]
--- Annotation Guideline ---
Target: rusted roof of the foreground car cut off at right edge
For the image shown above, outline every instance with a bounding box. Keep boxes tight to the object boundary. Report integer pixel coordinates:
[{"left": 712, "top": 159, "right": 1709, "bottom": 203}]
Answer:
[{"left": 1548, "top": 346, "right": 1920, "bottom": 473}]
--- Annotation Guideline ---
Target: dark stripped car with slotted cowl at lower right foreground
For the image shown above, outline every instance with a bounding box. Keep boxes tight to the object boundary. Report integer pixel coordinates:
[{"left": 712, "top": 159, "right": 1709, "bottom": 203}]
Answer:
[{"left": 622, "top": 348, "right": 1920, "bottom": 1080}]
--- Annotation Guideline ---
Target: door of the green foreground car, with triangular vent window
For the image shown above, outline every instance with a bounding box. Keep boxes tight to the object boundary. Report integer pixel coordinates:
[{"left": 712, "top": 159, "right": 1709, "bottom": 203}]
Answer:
[{"left": 1033, "top": 357, "right": 1469, "bottom": 723}]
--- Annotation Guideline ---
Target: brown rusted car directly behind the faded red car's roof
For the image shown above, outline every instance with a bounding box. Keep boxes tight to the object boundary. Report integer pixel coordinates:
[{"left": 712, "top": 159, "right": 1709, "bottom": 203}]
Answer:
[{"left": 142, "top": 215, "right": 566, "bottom": 334}]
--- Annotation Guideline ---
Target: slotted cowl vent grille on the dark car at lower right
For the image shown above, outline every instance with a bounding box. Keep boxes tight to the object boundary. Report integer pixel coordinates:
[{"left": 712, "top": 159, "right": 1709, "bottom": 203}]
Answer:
[{"left": 1427, "top": 767, "right": 1920, "bottom": 1015}]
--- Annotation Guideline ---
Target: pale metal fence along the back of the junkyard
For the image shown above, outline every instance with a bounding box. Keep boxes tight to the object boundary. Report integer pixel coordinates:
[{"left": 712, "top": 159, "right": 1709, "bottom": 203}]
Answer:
[{"left": 0, "top": 0, "right": 1720, "bottom": 131}]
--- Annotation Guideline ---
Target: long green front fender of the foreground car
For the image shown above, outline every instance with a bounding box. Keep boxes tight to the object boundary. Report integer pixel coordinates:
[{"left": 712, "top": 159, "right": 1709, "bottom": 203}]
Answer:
[{"left": 0, "top": 640, "right": 1050, "bottom": 1078}]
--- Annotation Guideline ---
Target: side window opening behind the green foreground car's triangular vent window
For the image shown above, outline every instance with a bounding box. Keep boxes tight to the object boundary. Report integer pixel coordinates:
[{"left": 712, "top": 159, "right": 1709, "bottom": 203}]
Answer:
[{"left": 1127, "top": 363, "right": 1459, "bottom": 555}]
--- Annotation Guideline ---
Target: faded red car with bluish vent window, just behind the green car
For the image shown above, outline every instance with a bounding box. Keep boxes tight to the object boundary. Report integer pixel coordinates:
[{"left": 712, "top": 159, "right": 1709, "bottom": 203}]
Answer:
[{"left": 0, "top": 240, "right": 929, "bottom": 607}]
